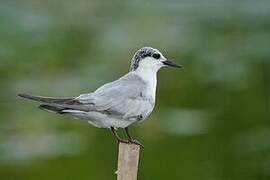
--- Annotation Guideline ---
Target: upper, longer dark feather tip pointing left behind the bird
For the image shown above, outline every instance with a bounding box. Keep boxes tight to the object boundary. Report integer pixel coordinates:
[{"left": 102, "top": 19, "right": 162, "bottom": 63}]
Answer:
[{"left": 18, "top": 94, "right": 74, "bottom": 104}]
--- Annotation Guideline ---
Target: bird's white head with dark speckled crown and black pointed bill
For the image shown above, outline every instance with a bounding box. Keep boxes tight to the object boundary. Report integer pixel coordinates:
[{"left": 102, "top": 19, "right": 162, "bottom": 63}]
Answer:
[{"left": 130, "top": 47, "right": 182, "bottom": 71}]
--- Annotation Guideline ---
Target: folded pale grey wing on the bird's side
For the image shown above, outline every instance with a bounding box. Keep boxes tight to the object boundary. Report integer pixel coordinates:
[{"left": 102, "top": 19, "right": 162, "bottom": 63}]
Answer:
[{"left": 77, "top": 74, "right": 154, "bottom": 119}]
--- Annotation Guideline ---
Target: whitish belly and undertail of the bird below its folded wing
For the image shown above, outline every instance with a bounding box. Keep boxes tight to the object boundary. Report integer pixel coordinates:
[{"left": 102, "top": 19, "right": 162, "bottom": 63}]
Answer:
[{"left": 64, "top": 110, "right": 136, "bottom": 128}]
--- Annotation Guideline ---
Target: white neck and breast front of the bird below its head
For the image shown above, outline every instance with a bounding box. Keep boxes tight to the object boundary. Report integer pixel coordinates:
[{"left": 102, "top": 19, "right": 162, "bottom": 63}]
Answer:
[{"left": 134, "top": 67, "right": 157, "bottom": 100}]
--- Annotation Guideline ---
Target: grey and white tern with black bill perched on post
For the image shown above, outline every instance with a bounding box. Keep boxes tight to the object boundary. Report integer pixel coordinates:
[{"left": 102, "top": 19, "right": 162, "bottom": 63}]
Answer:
[{"left": 18, "top": 47, "right": 182, "bottom": 146}]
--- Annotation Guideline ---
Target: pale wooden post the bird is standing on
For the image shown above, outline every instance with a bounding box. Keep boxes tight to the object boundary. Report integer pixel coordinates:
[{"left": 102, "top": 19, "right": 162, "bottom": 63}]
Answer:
[{"left": 116, "top": 143, "right": 140, "bottom": 180}]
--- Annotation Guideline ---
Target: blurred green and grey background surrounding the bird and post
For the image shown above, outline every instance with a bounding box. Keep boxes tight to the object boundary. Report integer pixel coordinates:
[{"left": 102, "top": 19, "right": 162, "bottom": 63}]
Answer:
[{"left": 0, "top": 0, "right": 270, "bottom": 180}]
